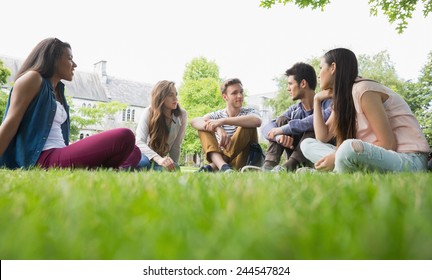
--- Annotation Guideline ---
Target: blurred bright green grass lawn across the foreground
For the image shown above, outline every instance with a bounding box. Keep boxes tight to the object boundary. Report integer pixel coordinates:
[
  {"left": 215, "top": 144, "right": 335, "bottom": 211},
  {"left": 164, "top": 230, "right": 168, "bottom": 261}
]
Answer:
[{"left": 0, "top": 167, "right": 432, "bottom": 260}]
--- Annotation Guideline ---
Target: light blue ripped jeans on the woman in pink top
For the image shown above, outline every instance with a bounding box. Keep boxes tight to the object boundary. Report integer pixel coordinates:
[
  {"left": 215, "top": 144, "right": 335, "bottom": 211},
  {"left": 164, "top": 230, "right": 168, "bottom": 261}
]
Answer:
[{"left": 300, "top": 138, "right": 427, "bottom": 173}]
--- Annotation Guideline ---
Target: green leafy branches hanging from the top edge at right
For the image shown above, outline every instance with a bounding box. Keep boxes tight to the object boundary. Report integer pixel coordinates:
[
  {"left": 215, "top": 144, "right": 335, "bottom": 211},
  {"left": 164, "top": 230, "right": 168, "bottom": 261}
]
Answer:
[{"left": 260, "top": 0, "right": 432, "bottom": 33}]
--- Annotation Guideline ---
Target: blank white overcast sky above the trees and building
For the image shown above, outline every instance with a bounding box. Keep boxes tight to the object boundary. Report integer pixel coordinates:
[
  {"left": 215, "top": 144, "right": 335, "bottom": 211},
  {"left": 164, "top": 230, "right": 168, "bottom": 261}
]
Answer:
[{"left": 0, "top": 0, "right": 432, "bottom": 95}]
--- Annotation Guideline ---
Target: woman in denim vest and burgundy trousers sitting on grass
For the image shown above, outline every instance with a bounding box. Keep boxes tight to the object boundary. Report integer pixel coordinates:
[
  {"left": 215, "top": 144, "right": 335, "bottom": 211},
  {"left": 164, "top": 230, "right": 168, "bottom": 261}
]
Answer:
[{"left": 0, "top": 38, "right": 140, "bottom": 169}]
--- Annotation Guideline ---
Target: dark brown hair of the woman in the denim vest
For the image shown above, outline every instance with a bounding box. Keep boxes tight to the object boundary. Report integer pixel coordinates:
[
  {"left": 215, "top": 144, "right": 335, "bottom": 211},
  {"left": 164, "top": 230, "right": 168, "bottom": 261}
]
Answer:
[{"left": 15, "top": 38, "right": 71, "bottom": 80}]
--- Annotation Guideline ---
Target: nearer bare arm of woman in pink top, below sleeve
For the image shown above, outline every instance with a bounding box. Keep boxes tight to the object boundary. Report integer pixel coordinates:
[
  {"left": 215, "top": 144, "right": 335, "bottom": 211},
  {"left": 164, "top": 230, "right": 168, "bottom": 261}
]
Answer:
[{"left": 360, "top": 91, "right": 397, "bottom": 151}]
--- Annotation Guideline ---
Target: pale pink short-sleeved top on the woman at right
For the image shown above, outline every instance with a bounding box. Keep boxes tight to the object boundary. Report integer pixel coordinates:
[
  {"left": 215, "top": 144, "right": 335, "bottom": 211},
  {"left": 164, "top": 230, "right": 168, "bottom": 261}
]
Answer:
[{"left": 352, "top": 80, "right": 430, "bottom": 153}]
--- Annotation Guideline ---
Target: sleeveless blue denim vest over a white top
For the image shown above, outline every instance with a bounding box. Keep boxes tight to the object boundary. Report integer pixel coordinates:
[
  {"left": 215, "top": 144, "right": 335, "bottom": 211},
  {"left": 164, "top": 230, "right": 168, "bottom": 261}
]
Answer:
[{"left": 0, "top": 78, "right": 70, "bottom": 169}]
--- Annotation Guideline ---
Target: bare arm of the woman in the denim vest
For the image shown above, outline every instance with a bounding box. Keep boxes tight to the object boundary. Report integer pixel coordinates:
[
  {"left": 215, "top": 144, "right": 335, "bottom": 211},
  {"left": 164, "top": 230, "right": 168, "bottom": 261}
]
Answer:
[{"left": 0, "top": 71, "right": 42, "bottom": 155}]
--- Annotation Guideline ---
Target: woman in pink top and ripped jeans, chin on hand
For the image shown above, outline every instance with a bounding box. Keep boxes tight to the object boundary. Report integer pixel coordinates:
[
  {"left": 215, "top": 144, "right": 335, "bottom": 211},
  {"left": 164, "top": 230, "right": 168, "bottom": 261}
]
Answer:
[{"left": 301, "top": 48, "right": 430, "bottom": 172}]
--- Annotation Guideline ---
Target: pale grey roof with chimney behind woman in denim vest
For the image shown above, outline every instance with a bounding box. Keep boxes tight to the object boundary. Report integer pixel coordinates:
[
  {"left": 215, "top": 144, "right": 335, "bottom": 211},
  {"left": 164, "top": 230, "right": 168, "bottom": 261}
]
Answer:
[{"left": 0, "top": 55, "right": 153, "bottom": 107}]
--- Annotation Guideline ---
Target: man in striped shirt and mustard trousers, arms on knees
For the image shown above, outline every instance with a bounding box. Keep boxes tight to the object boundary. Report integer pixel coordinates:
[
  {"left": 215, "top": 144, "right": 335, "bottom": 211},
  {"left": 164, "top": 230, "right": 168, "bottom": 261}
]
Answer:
[{"left": 191, "top": 78, "right": 261, "bottom": 172}]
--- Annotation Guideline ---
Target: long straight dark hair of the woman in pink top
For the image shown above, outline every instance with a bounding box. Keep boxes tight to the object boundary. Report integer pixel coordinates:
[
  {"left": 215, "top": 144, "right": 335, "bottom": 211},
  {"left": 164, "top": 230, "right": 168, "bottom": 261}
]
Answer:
[{"left": 324, "top": 48, "right": 358, "bottom": 146}]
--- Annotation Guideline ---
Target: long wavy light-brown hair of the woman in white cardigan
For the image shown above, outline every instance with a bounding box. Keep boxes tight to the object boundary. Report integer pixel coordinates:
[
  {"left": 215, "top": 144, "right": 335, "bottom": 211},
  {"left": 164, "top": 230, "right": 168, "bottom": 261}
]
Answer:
[{"left": 149, "top": 81, "right": 181, "bottom": 156}]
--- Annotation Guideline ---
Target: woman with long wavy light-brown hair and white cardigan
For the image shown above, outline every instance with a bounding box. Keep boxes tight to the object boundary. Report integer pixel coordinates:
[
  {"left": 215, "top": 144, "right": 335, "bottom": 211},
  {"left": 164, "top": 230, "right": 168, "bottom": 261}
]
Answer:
[{"left": 136, "top": 80, "right": 187, "bottom": 171}]
